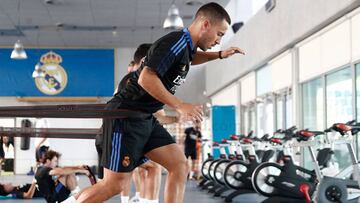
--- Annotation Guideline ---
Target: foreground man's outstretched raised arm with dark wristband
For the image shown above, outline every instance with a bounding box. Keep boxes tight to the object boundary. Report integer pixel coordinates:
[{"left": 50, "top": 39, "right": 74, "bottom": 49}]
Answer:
[{"left": 191, "top": 47, "right": 245, "bottom": 65}]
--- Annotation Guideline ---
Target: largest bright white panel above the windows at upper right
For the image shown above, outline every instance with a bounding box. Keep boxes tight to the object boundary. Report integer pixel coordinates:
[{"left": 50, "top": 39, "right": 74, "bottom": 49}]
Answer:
[{"left": 299, "top": 16, "right": 356, "bottom": 82}]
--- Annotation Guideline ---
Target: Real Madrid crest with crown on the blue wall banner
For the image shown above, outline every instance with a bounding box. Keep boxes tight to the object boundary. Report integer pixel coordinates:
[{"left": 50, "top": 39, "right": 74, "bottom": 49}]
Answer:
[{"left": 35, "top": 51, "right": 67, "bottom": 95}]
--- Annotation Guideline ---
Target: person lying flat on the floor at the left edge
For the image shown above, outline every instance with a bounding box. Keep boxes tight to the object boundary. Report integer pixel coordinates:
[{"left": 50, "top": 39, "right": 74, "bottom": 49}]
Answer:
[{"left": 0, "top": 179, "right": 42, "bottom": 199}]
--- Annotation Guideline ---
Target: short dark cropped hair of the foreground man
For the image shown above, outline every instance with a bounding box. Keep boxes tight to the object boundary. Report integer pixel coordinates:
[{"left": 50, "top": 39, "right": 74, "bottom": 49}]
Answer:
[{"left": 195, "top": 2, "right": 231, "bottom": 25}]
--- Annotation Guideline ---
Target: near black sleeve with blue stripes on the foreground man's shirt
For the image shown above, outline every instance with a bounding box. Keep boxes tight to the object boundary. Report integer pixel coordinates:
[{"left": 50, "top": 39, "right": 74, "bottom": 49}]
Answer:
[{"left": 144, "top": 38, "right": 186, "bottom": 77}]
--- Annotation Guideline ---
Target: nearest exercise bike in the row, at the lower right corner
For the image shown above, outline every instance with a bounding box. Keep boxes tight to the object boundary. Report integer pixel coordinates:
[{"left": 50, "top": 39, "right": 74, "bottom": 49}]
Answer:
[{"left": 253, "top": 124, "right": 359, "bottom": 203}]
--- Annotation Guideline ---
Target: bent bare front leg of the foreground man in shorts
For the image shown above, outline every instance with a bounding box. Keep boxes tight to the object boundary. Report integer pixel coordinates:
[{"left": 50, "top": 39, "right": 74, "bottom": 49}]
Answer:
[{"left": 146, "top": 144, "right": 189, "bottom": 203}]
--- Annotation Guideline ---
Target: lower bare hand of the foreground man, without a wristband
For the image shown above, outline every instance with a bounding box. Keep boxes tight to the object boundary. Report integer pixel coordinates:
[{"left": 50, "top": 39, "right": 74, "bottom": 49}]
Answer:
[{"left": 176, "top": 103, "right": 203, "bottom": 122}]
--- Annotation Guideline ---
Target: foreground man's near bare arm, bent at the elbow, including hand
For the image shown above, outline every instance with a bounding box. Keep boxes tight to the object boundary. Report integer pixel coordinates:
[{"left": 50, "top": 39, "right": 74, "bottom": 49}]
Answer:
[{"left": 138, "top": 66, "right": 202, "bottom": 121}]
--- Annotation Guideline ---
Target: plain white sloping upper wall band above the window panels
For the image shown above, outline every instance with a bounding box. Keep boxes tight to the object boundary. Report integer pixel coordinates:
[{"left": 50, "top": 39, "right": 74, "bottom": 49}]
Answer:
[{"left": 206, "top": 0, "right": 360, "bottom": 95}]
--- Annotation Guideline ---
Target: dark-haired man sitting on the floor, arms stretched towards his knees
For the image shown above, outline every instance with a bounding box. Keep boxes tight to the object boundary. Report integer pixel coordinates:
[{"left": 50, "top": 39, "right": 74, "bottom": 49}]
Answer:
[{"left": 35, "top": 150, "right": 96, "bottom": 203}]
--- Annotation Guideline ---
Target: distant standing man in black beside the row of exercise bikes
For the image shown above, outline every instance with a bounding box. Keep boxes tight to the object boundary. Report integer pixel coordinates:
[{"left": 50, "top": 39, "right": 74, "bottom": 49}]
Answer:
[{"left": 184, "top": 123, "right": 201, "bottom": 178}]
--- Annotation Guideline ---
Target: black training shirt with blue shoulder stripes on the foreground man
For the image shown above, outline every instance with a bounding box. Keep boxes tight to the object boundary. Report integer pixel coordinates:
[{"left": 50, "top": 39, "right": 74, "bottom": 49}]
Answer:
[{"left": 110, "top": 28, "right": 196, "bottom": 113}]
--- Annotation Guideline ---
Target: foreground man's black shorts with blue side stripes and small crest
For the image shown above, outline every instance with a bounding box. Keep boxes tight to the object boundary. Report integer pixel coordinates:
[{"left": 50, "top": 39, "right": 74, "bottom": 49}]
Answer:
[{"left": 101, "top": 114, "right": 175, "bottom": 172}]
